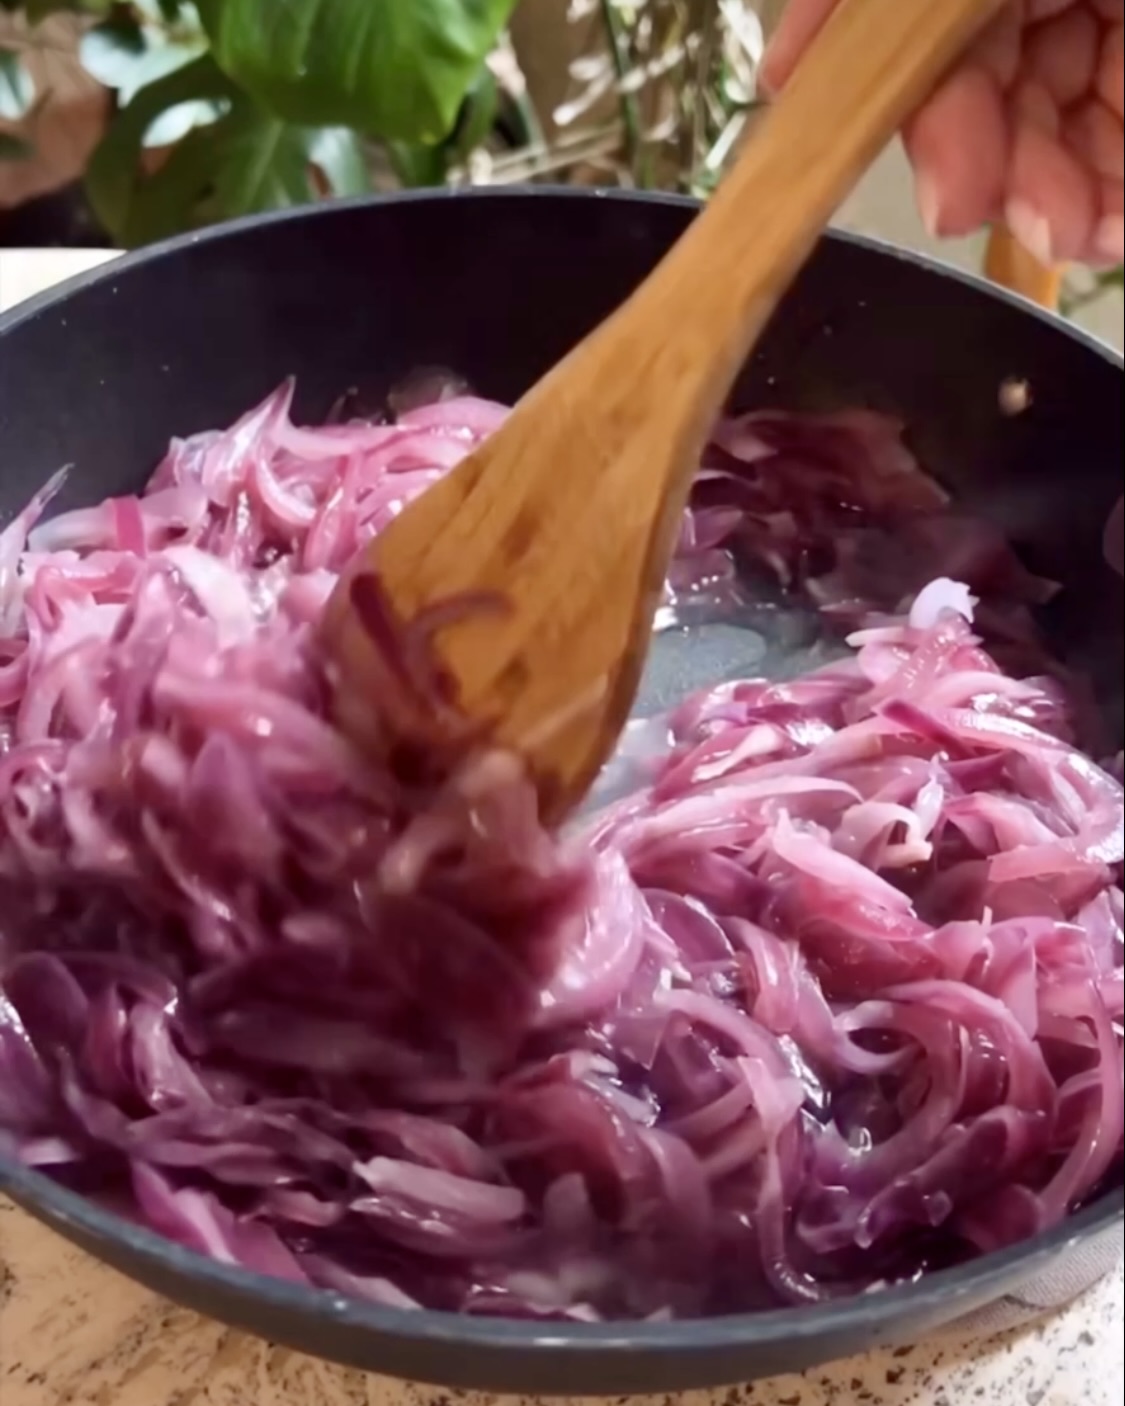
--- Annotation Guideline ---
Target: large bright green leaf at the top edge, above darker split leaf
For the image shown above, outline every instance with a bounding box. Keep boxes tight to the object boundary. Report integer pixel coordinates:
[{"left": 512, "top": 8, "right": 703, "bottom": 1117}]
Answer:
[{"left": 198, "top": 0, "right": 515, "bottom": 143}]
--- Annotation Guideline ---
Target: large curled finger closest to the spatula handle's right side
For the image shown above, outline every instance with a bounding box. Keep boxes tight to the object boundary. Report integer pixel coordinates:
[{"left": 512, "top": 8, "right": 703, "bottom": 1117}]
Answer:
[{"left": 904, "top": 66, "right": 1008, "bottom": 238}]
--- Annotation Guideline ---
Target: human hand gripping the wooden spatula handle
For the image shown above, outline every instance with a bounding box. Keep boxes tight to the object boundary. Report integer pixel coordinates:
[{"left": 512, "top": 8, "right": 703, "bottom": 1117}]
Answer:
[{"left": 762, "top": 0, "right": 1125, "bottom": 266}]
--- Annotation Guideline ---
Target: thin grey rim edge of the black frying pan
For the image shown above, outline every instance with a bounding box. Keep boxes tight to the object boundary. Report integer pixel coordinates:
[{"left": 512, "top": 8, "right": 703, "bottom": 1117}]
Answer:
[{"left": 0, "top": 186, "right": 1125, "bottom": 1358}]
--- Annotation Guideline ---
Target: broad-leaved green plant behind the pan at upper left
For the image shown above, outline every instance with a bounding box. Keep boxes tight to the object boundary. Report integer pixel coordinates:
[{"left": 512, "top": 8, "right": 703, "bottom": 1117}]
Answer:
[{"left": 0, "top": 0, "right": 516, "bottom": 246}]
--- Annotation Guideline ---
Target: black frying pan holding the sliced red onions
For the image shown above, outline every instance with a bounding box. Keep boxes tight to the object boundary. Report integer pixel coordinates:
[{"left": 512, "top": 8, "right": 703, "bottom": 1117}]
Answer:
[{"left": 0, "top": 188, "right": 1125, "bottom": 1395}]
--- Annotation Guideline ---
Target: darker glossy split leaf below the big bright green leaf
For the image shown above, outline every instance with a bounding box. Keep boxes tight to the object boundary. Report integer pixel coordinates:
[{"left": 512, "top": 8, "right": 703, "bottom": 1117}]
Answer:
[{"left": 87, "top": 58, "right": 370, "bottom": 247}]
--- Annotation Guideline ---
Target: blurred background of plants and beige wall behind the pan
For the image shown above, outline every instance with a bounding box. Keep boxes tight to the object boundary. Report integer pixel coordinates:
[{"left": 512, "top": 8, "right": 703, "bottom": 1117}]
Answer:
[{"left": 0, "top": 0, "right": 1122, "bottom": 346}]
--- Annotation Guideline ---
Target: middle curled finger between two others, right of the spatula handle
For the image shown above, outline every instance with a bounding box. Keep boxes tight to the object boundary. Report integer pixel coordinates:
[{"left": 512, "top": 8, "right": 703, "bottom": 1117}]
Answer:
[{"left": 1004, "top": 122, "right": 1100, "bottom": 264}]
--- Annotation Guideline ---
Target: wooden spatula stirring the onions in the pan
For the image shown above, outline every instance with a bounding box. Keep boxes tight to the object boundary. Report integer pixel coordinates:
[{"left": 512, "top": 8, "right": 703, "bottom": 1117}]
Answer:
[{"left": 323, "top": 0, "right": 1003, "bottom": 820}]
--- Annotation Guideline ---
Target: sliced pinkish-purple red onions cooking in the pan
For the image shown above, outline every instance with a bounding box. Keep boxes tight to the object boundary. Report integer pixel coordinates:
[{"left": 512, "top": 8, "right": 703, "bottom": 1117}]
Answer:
[{"left": 0, "top": 387, "right": 1125, "bottom": 1320}]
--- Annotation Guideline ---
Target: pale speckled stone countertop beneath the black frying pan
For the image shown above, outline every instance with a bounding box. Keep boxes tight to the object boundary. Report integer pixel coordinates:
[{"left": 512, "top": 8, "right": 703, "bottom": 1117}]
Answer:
[{"left": 0, "top": 250, "right": 1125, "bottom": 1406}]
